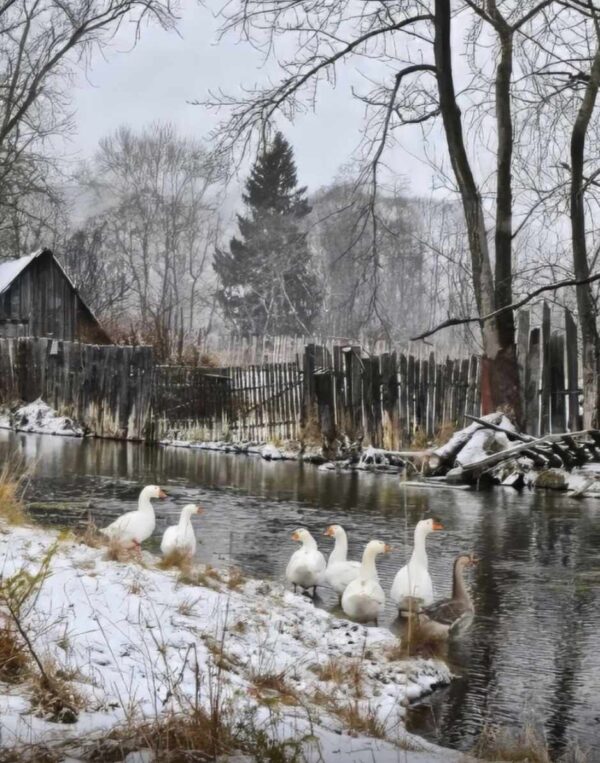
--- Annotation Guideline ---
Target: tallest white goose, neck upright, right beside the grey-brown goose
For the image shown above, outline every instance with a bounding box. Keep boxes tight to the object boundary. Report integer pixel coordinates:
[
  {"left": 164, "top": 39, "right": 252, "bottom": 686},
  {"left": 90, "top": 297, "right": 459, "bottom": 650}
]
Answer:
[{"left": 390, "top": 519, "right": 444, "bottom": 612}]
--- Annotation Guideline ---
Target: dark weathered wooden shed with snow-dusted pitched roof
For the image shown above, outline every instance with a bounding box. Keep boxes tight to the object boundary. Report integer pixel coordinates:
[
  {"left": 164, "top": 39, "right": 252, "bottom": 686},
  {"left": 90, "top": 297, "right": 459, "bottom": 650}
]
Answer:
[{"left": 0, "top": 249, "right": 111, "bottom": 344}]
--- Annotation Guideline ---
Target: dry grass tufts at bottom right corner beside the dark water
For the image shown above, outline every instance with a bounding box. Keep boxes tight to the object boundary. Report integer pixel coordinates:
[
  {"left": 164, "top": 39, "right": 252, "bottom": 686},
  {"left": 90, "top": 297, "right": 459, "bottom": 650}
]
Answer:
[{"left": 471, "top": 725, "right": 591, "bottom": 763}]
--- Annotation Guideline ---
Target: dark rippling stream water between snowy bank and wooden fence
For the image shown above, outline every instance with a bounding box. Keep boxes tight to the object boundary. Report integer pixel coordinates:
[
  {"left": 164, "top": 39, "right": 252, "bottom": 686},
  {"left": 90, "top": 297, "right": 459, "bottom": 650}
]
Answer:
[{"left": 0, "top": 432, "right": 600, "bottom": 760}]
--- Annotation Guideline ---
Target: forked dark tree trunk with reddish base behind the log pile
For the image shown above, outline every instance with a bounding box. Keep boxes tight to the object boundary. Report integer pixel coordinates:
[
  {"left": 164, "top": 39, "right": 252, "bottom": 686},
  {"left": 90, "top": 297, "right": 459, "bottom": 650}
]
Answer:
[{"left": 434, "top": 0, "right": 521, "bottom": 420}]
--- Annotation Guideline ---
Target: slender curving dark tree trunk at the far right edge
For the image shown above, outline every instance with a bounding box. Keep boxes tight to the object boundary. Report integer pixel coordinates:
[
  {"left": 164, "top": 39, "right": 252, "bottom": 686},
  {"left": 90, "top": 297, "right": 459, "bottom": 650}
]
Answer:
[{"left": 571, "top": 47, "right": 600, "bottom": 429}]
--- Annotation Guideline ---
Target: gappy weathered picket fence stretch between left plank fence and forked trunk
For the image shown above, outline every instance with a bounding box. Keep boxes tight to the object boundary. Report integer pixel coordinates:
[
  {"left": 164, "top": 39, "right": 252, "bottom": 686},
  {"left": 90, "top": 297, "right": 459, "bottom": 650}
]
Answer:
[{"left": 153, "top": 344, "right": 481, "bottom": 449}]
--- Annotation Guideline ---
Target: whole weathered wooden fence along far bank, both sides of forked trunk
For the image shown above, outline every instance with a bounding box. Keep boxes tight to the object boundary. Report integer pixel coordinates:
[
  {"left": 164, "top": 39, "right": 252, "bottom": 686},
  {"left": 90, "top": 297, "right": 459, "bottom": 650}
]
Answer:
[{"left": 0, "top": 303, "right": 582, "bottom": 450}]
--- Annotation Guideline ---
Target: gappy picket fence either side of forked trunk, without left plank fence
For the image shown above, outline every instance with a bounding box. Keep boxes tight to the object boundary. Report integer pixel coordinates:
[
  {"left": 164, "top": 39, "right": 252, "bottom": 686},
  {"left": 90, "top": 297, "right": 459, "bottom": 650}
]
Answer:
[{"left": 153, "top": 303, "right": 581, "bottom": 450}]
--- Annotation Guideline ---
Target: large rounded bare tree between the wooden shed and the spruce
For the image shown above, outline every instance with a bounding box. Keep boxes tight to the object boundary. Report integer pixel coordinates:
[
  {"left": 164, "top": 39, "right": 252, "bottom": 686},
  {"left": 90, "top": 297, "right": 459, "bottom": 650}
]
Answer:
[{"left": 82, "top": 124, "right": 223, "bottom": 360}]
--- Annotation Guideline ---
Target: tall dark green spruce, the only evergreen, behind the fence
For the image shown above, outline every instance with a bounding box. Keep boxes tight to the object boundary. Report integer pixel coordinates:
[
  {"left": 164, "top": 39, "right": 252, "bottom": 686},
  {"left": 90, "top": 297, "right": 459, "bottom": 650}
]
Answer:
[{"left": 213, "top": 132, "right": 322, "bottom": 336}]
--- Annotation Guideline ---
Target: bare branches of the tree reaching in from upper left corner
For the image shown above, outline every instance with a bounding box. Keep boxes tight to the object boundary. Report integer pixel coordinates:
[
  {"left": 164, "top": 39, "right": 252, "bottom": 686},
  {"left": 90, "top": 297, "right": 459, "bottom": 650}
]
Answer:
[{"left": 0, "top": 0, "right": 175, "bottom": 243}]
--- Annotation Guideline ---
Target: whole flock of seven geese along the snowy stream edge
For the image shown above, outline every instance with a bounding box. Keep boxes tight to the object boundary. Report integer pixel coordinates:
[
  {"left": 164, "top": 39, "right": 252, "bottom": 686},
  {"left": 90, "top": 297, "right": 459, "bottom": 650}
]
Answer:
[{"left": 100, "top": 485, "right": 477, "bottom": 633}]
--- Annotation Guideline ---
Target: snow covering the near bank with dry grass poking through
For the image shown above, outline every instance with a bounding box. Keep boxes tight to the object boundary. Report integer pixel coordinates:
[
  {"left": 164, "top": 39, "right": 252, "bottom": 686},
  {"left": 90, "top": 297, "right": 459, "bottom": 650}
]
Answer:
[{"left": 0, "top": 525, "right": 464, "bottom": 763}]
